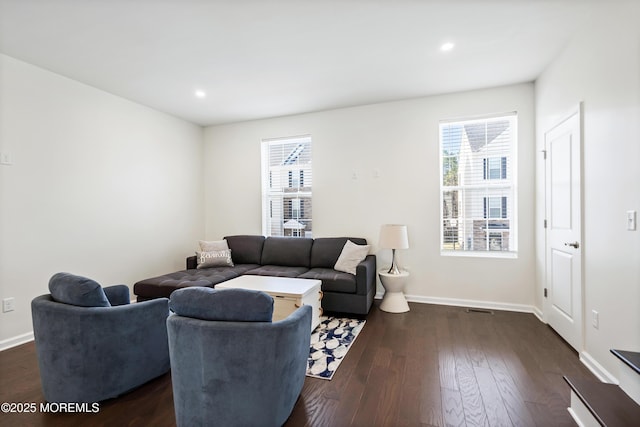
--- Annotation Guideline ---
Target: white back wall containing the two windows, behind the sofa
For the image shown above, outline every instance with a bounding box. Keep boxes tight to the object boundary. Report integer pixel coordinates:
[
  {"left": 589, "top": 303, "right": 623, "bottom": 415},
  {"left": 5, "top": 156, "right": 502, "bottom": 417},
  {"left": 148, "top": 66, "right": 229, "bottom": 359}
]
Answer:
[{"left": 205, "top": 84, "right": 535, "bottom": 309}]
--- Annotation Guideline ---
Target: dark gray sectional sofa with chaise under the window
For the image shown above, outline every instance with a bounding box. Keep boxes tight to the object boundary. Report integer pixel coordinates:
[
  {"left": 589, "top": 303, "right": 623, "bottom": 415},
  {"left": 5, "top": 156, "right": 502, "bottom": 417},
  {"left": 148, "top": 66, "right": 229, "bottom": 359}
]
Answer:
[{"left": 133, "top": 235, "right": 376, "bottom": 315}]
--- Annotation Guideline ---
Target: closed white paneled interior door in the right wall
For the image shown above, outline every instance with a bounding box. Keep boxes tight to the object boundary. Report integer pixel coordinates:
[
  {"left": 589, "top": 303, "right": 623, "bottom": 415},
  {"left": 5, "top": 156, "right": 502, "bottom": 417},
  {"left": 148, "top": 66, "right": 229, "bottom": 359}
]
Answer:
[{"left": 545, "top": 111, "right": 583, "bottom": 351}]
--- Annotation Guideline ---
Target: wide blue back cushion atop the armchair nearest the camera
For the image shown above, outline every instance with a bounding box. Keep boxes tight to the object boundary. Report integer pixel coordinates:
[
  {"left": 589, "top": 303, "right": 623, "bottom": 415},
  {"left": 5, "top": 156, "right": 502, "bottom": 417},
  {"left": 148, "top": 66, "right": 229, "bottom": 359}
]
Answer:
[{"left": 169, "top": 287, "right": 273, "bottom": 322}]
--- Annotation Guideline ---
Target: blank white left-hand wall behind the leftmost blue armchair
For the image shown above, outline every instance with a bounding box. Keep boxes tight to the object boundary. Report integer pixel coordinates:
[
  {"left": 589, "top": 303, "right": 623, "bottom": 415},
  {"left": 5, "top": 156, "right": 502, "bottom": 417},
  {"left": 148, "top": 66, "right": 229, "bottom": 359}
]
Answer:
[{"left": 0, "top": 55, "right": 204, "bottom": 349}]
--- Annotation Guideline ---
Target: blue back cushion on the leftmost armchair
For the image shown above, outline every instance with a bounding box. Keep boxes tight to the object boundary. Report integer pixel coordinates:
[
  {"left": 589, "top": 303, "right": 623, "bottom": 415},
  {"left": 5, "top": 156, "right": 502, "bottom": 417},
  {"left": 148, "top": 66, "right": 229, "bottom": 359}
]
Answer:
[{"left": 49, "top": 273, "right": 111, "bottom": 307}]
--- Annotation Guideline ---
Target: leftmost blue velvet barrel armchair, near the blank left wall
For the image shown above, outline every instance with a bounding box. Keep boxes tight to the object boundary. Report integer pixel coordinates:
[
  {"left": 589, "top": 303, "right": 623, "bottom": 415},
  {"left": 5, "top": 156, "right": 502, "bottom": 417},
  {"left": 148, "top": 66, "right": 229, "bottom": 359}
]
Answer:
[{"left": 31, "top": 273, "right": 170, "bottom": 402}]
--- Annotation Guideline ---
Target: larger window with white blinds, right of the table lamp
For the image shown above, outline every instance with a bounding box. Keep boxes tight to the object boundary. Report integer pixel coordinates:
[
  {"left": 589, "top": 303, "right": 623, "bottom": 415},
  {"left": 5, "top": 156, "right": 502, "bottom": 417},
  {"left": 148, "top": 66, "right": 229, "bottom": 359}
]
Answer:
[{"left": 440, "top": 113, "right": 518, "bottom": 255}]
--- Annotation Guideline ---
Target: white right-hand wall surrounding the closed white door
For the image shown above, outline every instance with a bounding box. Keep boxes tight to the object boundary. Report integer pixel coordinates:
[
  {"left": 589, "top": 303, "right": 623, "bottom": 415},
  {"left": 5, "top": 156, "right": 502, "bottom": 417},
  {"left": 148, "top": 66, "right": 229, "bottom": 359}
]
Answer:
[{"left": 536, "top": 2, "right": 640, "bottom": 382}]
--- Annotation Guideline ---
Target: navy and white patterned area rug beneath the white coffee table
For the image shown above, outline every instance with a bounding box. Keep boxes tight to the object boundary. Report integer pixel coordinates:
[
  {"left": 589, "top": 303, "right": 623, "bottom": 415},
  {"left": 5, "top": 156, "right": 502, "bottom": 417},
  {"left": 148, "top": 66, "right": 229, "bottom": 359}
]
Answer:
[{"left": 307, "top": 316, "right": 366, "bottom": 380}]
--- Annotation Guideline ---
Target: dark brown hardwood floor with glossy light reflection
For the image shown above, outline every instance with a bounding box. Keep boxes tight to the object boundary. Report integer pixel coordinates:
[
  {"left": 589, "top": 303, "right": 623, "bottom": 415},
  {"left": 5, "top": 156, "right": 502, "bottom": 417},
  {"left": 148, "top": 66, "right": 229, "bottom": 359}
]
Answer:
[{"left": 0, "top": 301, "right": 595, "bottom": 427}]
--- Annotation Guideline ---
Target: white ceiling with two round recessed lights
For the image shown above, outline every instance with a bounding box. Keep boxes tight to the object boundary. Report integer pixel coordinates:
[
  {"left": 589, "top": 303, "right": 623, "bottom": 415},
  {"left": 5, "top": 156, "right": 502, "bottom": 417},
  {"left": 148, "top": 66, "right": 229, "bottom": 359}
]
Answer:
[{"left": 0, "top": 0, "right": 612, "bottom": 126}]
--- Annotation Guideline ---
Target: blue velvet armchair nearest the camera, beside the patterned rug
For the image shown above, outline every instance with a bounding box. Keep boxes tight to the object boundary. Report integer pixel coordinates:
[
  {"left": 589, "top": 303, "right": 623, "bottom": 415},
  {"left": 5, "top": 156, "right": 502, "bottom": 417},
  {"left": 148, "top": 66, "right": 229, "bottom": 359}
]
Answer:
[{"left": 167, "top": 287, "right": 311, "bottom": 427}]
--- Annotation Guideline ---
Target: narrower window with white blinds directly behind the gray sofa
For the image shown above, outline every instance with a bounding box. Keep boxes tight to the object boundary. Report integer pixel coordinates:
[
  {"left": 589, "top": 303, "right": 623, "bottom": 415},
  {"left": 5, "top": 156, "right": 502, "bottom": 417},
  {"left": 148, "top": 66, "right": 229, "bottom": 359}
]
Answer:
[{"left": 262, "top": 135, "right": 313, "bottom": 237}]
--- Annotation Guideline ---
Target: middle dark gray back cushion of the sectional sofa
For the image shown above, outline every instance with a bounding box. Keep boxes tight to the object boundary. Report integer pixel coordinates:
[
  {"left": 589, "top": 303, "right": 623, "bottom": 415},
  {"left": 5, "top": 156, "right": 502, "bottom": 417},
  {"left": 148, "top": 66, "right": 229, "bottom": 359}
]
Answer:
[{"left": 260, "top": 237, "right": 313, "bottom": 268}]
